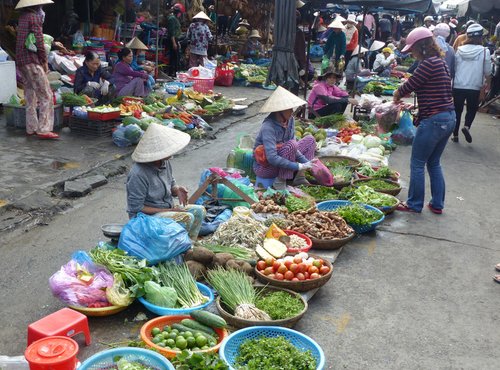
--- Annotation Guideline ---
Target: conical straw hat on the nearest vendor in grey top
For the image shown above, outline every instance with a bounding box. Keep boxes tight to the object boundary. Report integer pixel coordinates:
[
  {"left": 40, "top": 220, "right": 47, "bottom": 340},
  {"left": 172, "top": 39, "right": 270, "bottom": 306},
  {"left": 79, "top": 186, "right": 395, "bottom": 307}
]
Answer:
[{"left": 132, "top": 123, "right": 191, "bottom": 163}]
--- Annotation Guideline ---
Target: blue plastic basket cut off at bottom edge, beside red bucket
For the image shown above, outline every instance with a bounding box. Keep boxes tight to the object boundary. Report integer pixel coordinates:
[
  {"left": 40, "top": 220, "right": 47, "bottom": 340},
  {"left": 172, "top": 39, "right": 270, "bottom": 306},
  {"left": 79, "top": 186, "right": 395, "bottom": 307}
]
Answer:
[{"left": 78, "top": 347, "right": 175, "bottom": 370}]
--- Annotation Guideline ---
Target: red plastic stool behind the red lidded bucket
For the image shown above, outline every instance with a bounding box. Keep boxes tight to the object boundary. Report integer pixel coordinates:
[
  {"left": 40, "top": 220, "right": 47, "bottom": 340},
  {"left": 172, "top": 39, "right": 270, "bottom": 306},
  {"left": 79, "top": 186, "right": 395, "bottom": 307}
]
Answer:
[{"left": 28, "top": 308, "right": 91, "bottom": 346}]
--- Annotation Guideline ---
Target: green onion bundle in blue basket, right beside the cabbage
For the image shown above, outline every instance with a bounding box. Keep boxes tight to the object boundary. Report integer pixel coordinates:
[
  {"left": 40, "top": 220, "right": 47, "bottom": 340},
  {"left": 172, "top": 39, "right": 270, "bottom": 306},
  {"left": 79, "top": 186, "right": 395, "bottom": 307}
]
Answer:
[{"left": 157, "top": 262, "right": 207, "bottom": 308}]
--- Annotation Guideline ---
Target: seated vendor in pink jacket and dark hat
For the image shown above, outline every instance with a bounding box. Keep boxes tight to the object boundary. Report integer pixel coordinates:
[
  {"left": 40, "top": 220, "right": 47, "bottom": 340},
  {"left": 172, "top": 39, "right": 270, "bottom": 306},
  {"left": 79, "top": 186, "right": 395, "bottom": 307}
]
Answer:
[{"left": 308, "top": 68, "right": 349, "bottom": 117}]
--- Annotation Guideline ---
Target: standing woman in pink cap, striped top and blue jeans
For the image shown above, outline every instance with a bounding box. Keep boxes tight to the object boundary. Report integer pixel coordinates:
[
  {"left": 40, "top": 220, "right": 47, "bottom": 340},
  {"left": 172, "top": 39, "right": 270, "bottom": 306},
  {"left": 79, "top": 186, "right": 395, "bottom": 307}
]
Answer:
[{"left": 394, "top": 27, "right": 456, "bottom": 214}]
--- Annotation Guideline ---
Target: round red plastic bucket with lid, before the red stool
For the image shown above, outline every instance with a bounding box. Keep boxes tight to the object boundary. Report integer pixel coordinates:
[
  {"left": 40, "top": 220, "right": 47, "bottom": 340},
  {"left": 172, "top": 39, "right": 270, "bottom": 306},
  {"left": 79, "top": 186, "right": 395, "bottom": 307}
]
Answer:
[{"left": 24, "top": 337, "right": 78, "bottom": 370}]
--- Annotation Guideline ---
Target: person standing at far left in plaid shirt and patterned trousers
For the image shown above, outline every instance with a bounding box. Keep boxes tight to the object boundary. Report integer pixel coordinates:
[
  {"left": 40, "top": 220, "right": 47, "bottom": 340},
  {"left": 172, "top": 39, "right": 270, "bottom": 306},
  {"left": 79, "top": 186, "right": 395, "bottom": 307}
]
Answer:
[{"left": 16, "top": 0, "right": 59, "bottom": 139}]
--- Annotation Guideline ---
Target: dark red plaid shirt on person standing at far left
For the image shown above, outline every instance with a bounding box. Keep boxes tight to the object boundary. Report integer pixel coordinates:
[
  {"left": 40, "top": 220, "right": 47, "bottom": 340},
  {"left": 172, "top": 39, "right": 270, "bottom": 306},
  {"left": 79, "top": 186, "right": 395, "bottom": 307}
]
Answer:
[{"left": 16, "top": 11, "right": 47, "bottom": 67}]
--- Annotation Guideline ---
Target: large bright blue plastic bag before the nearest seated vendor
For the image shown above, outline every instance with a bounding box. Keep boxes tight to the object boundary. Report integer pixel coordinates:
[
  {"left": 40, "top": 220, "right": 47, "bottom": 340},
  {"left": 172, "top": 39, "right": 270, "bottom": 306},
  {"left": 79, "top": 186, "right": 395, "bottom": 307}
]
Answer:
[{"left": 118, "top": 213, "right": 191, "bottom": 265}]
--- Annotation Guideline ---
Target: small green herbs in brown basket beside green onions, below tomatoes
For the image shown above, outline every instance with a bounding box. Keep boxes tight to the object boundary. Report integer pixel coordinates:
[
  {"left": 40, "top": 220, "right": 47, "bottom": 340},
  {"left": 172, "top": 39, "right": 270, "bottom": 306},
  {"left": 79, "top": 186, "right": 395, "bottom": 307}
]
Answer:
[{"left": 255, "top": 291, "right": 304, "bottom": 320}]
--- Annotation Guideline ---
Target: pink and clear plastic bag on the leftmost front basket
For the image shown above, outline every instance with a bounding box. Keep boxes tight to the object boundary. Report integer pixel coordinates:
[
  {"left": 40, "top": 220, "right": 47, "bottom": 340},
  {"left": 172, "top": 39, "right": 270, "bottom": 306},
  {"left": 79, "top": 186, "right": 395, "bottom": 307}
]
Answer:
[{"left": 49, "top": 251, "right": 113, "bottom": 307}]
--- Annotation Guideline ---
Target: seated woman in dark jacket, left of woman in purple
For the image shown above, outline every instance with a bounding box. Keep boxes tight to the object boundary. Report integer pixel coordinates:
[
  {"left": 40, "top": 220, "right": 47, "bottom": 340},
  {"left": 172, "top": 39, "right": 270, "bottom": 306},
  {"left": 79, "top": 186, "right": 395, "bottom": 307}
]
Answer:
[{"left": 74, "top": 51, "right": 114, "bottom": 103}]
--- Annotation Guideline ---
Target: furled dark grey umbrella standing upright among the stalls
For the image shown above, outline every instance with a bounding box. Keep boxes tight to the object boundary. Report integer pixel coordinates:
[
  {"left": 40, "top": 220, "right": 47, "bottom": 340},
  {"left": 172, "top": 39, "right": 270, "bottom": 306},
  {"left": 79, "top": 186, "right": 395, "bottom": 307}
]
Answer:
[{"left": 266, "top": 0, "right": 299, "bottom": 87}]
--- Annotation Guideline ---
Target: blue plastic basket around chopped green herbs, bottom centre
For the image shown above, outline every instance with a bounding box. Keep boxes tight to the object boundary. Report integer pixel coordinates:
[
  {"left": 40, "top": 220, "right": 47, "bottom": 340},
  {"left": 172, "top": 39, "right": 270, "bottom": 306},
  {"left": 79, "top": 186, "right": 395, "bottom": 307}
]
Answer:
[{"left": 219, "top": 326, "right": 325, "bottom": 370}]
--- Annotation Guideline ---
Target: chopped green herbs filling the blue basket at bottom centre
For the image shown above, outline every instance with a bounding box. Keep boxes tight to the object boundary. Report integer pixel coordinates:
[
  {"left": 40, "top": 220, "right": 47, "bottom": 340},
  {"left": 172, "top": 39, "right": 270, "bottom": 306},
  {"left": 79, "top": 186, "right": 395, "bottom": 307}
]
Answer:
[{"left": 236, "top": 336, "right": 316, "bottom": 370}]
